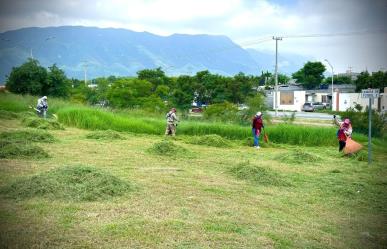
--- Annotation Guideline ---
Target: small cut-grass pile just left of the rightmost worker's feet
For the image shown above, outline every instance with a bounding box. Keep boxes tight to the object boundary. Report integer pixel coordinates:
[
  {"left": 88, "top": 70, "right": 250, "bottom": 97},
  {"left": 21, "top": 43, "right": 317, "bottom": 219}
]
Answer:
[{"left": 274, "top": 149, "right": 322, "bottom": 165}]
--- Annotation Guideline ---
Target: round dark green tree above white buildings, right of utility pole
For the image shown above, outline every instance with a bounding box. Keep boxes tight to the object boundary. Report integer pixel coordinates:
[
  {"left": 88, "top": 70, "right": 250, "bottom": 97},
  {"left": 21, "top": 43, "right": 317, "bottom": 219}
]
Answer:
[{"left": 292, "top": 61, "right": 326, "bottom": 89}]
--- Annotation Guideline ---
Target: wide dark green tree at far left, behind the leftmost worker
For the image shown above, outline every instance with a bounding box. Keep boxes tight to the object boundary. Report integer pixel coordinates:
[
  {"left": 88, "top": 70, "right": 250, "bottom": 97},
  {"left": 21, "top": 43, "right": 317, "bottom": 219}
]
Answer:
[{"left": 6, "top": 58, "right": 47, "bottom": 95}]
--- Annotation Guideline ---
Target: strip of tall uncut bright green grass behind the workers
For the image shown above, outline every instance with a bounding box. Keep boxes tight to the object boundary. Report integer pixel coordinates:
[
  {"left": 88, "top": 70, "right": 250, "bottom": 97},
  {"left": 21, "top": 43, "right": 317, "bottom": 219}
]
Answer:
[{"left": 0, "top": 94, "right": 367, "bottom": 146}]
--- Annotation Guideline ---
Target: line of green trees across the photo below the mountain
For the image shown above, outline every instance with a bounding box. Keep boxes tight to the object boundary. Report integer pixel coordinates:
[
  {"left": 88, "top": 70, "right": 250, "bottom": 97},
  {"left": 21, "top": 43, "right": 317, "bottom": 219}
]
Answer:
[{"left": 6, "top": 59, "right": 387, "bottom": 109}]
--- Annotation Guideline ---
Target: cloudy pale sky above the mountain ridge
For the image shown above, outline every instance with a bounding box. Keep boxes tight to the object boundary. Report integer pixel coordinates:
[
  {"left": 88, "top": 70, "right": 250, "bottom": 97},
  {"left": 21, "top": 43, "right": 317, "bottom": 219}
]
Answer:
[{"left": 0, "top": 0, "right": 387, "bottom": 72}]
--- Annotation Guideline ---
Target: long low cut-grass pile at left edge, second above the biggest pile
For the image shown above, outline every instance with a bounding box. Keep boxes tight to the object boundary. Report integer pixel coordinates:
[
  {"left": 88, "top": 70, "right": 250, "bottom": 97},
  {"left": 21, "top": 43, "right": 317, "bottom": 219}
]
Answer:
[{"left": 0, "top": 129, "right": 55, "bottom": 143}]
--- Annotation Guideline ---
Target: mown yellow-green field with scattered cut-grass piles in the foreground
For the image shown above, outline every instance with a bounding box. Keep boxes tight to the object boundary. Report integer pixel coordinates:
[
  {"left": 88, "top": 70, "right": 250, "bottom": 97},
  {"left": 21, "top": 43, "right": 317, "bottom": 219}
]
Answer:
[{"left": 0, "top": 94, "right": 387, "bottom": 248}]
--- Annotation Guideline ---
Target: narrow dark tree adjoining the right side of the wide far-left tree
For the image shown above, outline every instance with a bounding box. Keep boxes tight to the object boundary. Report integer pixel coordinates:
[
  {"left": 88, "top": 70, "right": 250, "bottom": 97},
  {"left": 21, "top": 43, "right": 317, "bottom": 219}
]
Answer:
[{"left": 42, "top": 64, "right": 70, "bottom": 98}]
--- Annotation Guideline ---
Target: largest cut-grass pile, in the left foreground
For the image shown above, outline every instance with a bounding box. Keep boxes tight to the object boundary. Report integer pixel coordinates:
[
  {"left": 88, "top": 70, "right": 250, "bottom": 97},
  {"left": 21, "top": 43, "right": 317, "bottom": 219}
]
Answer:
[{"left": 0, "top": 166, "right": 134, "bottom": 201}]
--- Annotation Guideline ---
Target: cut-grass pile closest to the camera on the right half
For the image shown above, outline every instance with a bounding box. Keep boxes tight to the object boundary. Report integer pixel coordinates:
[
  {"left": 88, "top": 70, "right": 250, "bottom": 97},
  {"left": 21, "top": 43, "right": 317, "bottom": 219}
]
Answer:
[{"left": 229, "top": 161, "right": 290, "bottom": 186}]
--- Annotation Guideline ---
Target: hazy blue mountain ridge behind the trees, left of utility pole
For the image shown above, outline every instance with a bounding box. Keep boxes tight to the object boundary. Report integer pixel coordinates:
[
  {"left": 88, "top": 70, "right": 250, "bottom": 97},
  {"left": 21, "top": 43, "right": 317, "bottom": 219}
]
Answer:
[{"left": 0, "top": 26, "right": 310, "bottom": 83}]
